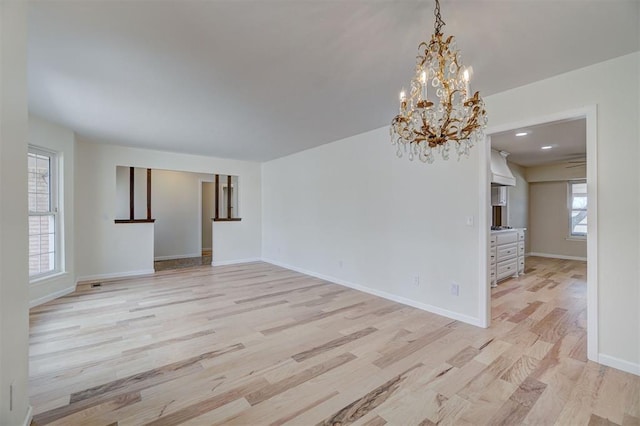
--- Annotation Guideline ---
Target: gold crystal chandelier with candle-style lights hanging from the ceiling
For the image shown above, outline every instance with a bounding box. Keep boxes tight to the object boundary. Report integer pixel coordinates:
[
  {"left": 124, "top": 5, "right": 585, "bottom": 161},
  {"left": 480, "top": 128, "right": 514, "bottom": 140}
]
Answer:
[{"left": 390, "top": 0, "right": 487, "bottom": 163}]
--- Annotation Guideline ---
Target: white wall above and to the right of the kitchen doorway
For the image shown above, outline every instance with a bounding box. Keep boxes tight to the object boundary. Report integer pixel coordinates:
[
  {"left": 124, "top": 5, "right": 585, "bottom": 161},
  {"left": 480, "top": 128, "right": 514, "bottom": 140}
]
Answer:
[{"left": 486, "top": 52, "right": 640, "bottom": 373}]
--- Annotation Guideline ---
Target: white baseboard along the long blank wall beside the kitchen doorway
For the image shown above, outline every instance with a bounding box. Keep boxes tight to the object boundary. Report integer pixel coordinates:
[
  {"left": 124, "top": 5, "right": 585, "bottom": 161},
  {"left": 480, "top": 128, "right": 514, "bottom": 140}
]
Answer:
[{"left": 262, "top": 258, "right": 482, "bottom": 327}]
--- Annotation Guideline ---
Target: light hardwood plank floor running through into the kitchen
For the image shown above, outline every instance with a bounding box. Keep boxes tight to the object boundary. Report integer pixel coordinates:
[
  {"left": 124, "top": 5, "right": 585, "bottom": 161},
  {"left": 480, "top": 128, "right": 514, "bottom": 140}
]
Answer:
[{"left": 30, "top": 257, "right": 640, "bottom": 426}]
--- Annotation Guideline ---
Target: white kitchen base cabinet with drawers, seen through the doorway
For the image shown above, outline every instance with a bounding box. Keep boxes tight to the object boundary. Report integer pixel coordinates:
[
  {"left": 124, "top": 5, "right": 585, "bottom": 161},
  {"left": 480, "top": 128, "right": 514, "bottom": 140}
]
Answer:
[{"left": 489, "top": 229, "right": 525, "bottom": 287}]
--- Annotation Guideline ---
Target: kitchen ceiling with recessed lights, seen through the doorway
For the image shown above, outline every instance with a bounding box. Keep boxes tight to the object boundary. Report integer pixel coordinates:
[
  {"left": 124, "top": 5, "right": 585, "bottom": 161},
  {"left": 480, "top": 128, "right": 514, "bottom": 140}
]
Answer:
[{"left": 491, "top": 119, "right": 587, "bottom": 167}]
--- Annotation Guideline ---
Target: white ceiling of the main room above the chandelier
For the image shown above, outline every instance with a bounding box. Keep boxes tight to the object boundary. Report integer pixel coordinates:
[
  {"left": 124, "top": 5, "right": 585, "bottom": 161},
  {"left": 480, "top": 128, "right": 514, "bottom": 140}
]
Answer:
[{"left": 28, "top": 0, "right": 640, "bottom": 161}]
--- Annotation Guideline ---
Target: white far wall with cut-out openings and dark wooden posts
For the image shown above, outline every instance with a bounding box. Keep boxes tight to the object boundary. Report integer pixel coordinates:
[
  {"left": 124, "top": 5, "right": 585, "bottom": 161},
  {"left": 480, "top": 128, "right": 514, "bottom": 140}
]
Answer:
[{"left": 75, "top": 138, "right": 261, "bottom": 281}]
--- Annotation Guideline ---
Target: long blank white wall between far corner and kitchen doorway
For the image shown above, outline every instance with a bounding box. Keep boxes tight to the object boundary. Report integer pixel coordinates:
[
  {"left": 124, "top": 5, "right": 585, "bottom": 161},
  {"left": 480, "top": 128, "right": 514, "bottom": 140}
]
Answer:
[{"left": 262, "top": 127, "right": 488, "bottom": 323}]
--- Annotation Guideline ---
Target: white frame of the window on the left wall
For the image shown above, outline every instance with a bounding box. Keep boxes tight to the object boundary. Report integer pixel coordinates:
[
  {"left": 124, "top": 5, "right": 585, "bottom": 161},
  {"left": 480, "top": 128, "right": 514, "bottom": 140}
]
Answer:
[{"left": 27, "top": 145, "right": 63, "bottom": 282}]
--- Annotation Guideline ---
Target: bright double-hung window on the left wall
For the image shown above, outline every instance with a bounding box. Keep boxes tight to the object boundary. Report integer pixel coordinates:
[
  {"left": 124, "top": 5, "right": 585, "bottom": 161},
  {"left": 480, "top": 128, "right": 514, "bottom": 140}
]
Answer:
[{"left": 28, "top": 146, "right": 60, "bottom": 278}]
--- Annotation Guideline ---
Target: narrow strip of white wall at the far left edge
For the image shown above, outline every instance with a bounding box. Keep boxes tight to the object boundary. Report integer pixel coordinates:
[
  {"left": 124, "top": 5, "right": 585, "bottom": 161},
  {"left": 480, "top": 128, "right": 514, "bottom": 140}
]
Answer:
[{"left": 0, "top": 1, "right": 30, "bottom": 425}]
